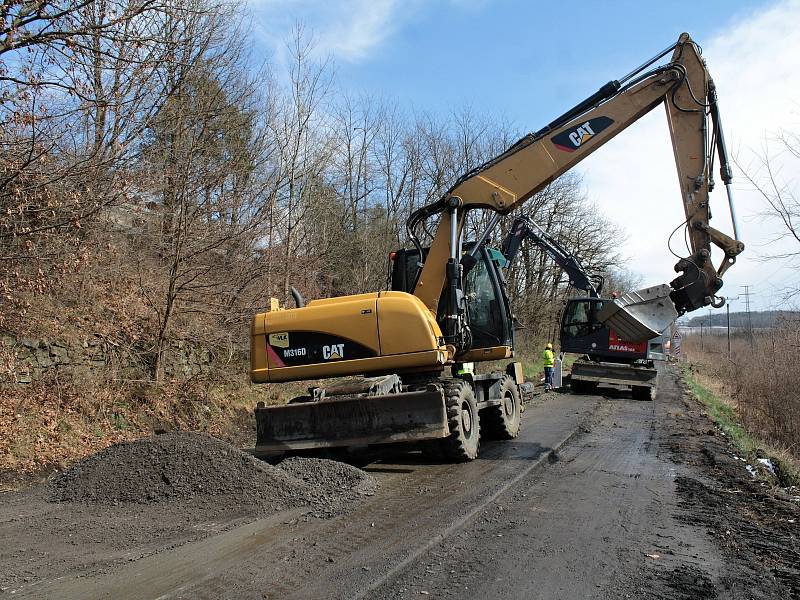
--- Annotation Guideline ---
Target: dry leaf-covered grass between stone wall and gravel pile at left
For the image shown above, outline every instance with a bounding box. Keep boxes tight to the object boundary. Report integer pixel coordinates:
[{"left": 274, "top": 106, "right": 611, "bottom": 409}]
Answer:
[{"left": 0, "top": 368, "right": 281, "bottom": 490}]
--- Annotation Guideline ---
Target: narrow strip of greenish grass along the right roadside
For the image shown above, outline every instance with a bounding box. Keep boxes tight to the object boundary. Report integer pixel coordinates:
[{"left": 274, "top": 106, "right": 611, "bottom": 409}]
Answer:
[{"left": 681, "top": 364, "right": 800, "bottom": 487}]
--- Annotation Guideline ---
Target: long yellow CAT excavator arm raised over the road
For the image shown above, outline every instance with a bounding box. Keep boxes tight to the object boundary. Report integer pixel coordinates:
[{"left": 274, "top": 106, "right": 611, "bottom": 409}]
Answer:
[{"left": 407, "top": 33, "right": 744, "bottom": 346}]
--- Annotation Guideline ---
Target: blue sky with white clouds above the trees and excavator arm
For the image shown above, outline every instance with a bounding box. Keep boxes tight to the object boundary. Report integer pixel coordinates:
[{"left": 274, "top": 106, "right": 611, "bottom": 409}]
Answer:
[{"left": 250, "top": 0, "right": 800, "bottom": 310}]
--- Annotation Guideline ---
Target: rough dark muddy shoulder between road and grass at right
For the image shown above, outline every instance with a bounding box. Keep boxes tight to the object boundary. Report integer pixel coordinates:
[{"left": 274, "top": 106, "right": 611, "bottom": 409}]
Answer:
[{"left": 622, "top": 368, "right": 800, "bottom": 600}]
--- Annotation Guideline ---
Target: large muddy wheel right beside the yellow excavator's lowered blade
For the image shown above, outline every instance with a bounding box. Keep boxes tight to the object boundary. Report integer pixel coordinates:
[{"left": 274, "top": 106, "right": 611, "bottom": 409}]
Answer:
[{"left": 441, "top": 379, "right": 481, "bottom": 462}]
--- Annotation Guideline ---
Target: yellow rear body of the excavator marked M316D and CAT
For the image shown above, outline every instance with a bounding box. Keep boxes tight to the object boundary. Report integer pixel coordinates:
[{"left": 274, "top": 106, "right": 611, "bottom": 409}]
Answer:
[{"left": 250, "top": 292, "right": 453, "bottom": 383}]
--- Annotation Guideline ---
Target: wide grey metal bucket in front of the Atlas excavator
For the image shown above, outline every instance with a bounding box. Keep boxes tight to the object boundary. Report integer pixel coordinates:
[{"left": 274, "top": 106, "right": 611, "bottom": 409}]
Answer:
[{"left": 598, "top": 284, "right": 678, "bottom": 342}]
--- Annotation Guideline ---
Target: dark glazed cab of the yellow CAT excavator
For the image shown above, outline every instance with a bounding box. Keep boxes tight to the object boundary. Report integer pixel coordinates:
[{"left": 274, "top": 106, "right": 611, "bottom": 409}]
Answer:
[{"left": 391, "top": 242, "right": 514, "bottom": 350}]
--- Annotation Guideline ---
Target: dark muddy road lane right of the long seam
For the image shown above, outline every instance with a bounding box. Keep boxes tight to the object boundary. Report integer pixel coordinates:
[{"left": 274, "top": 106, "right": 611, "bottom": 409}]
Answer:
[{"left": 356, "top": 380, "right": 713, "bottom": 599}]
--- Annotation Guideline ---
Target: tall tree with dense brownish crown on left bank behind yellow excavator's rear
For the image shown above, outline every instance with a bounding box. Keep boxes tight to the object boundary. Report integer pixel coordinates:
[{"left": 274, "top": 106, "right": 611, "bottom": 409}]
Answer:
[{"left": 140, "top": 10, "right": 274, "bottom": 380}]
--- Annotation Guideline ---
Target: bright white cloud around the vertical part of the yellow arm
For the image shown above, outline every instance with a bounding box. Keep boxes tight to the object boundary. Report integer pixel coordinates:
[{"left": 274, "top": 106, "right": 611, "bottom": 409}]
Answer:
[{"left": 581, "top": 0, "right": 800, "bottom": 310}]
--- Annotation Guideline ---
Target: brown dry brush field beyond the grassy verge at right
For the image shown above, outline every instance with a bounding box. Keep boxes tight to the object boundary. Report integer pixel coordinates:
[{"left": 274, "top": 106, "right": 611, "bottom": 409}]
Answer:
[{"left": 682, "top": 322, "right": 800, "bottom": 459}]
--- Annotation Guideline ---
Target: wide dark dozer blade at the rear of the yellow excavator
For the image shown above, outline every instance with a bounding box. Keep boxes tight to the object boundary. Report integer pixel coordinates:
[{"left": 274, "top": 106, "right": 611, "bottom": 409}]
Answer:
[{"left": 255, "top": 391, "right": 450, "bottom": 453}]
